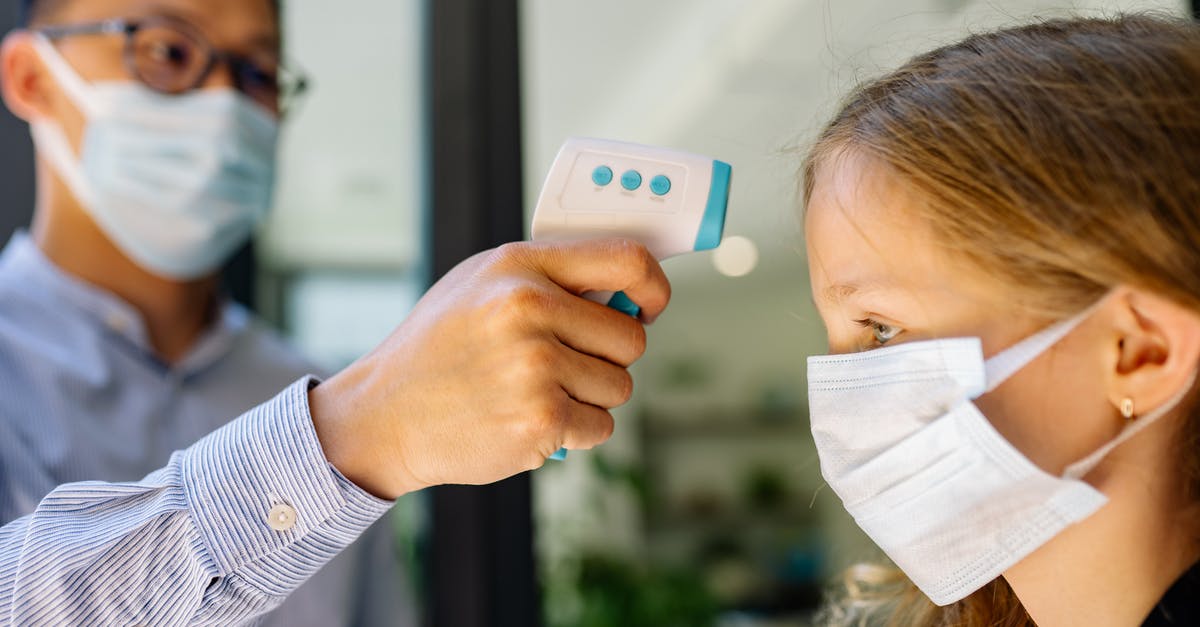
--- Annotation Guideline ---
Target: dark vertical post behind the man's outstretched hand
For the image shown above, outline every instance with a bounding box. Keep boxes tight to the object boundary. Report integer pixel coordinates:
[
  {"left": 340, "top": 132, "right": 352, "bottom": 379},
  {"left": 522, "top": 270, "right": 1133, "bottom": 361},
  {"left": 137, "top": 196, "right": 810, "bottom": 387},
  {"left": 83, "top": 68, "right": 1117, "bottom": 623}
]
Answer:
[{"left": 426, "top": 0, "right": 541, "bottom": 627}]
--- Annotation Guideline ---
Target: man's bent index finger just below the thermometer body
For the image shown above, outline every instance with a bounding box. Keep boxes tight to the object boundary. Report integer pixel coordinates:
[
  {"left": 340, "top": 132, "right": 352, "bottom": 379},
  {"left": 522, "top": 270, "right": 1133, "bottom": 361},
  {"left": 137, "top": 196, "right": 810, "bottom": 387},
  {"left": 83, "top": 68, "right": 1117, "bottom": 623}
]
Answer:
[{"left": 508, "top": 238, "right": 671, "bottom": 324}]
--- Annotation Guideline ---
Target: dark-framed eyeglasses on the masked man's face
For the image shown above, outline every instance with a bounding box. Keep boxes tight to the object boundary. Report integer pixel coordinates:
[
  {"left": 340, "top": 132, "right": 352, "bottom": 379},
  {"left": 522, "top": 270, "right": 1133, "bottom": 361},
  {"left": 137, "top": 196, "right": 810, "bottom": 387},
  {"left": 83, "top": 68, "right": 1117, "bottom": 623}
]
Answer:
[{"left": 36, "top": 16, "right": 308, "bottom": 115}]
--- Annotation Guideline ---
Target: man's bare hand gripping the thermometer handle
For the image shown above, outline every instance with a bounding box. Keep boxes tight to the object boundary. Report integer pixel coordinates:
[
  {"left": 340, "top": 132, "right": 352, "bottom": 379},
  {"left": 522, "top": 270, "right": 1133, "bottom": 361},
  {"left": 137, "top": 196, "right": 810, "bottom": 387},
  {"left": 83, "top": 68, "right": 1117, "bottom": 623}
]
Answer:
[{"left": 310, "top": 239, "right": 671, "bottom": 498}]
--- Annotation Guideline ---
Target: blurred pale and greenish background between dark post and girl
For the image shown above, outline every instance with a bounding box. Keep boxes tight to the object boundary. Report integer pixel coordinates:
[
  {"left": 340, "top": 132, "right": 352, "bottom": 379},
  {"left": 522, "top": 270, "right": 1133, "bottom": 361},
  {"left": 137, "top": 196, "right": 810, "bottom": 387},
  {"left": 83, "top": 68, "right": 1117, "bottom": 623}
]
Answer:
[{"left": 522, "top": 0, "right": 1183, "bottom": 627}]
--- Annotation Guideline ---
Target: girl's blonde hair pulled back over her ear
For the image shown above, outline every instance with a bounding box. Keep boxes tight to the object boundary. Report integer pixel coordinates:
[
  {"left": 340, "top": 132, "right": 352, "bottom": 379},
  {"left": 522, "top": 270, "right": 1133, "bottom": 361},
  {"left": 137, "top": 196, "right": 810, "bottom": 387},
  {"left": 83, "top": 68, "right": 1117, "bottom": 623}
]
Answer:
[{"left": 804, "top": 14, "right": 1200, "bottom": 627}]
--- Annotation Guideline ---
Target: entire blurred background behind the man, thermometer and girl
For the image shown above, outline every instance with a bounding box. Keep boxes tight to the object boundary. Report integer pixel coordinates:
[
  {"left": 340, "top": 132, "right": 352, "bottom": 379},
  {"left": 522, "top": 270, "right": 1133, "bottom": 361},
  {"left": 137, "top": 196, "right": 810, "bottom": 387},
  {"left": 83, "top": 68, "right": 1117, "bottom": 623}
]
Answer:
[{"left": 0, "top": 0, "right": 1194, "bottom": 627}]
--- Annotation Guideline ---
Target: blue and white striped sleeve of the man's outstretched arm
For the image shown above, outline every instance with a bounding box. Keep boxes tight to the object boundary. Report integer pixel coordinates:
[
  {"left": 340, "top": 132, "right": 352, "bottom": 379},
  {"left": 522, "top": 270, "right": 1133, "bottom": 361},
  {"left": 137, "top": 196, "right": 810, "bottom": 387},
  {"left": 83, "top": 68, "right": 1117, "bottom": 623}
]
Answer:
[{"left": 0, "top": 377, "right": 392, "bottom": 625}]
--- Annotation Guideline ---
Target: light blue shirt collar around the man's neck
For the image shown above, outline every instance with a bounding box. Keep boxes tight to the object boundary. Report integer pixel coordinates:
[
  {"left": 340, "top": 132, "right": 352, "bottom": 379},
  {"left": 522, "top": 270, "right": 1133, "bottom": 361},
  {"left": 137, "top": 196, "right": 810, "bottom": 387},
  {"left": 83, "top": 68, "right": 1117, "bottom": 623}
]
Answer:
[{"left": 0, "top": 231, "right": 251, "bottom": 376}]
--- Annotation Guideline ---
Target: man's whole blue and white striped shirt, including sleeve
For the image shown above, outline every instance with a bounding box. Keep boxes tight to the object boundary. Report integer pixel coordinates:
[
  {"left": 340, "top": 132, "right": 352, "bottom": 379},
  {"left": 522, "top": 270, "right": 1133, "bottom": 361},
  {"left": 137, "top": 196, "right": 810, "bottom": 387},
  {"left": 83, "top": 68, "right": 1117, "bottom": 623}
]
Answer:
[{"left": 0, "top": 235, "right": 413, "bottom": 626}]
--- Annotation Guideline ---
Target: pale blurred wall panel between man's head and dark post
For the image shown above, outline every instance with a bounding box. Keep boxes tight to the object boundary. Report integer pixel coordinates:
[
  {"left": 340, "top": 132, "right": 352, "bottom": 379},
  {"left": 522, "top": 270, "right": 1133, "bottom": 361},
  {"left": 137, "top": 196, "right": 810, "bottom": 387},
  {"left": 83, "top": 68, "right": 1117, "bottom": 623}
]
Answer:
[{"left": 260, "top": 0, "right": 425, "bottom": 269}]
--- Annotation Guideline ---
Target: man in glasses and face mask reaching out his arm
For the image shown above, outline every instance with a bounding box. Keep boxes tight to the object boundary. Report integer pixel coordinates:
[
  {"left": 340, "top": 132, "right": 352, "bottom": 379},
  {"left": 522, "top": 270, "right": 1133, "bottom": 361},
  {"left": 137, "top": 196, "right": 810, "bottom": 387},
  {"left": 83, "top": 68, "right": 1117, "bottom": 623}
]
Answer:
[{"left": 0, "top": 0, "right": 667, "bottom": 625}]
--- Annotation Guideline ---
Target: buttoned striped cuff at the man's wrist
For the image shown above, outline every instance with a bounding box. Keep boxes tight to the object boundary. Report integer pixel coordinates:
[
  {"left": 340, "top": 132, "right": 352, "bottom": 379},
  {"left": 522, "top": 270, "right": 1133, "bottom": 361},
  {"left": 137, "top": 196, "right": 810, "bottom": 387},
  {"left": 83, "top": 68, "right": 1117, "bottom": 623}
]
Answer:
[{"left": 180, "top": 376, "right": 394, "bottom": 595}]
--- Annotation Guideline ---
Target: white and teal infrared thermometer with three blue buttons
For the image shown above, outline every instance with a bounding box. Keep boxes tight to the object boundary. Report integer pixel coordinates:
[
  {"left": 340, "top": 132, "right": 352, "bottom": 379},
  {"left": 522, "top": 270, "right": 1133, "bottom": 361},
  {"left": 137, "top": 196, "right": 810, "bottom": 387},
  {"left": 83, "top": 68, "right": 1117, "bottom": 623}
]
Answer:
[{"left": 530, "top": 138, "right": 733, "bottom": 460}]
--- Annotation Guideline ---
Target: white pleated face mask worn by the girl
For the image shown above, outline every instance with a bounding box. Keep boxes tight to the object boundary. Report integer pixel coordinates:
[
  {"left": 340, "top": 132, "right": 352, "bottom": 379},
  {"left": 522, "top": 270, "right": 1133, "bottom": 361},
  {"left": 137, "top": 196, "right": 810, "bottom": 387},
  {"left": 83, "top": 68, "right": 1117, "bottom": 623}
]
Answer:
[{"left": 808, "top": 300, "right": 1195, "bottom": 605}]
